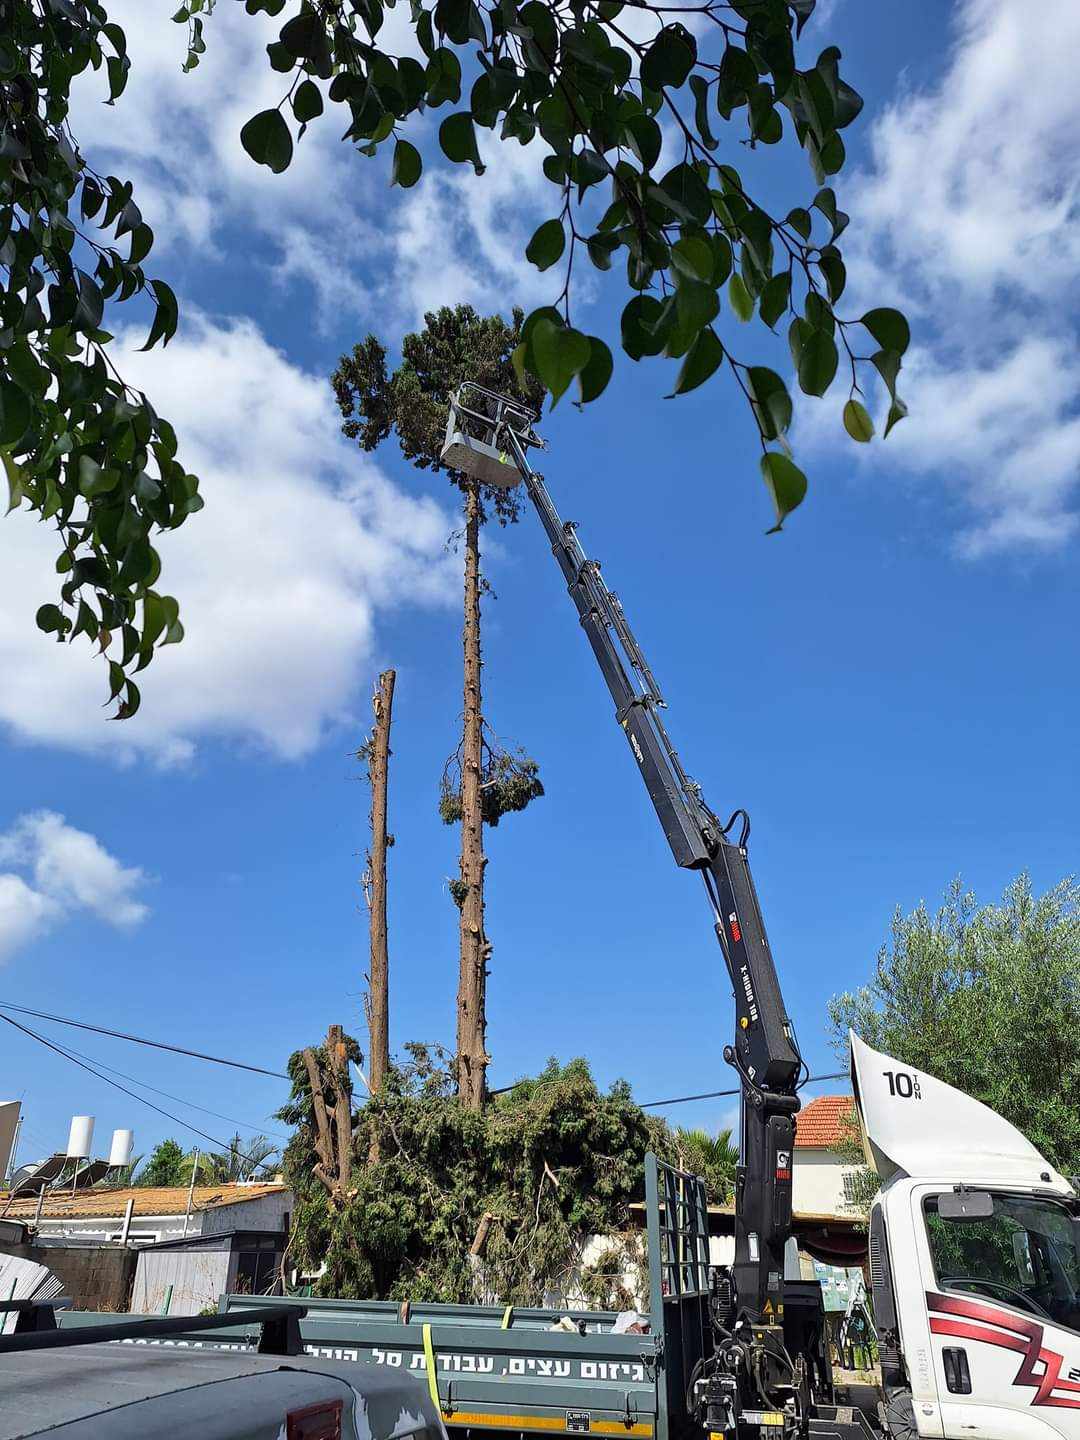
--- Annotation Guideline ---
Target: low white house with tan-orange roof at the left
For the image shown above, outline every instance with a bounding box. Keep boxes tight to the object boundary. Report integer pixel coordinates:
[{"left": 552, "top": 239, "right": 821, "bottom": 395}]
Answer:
[{"left": 0, "top": 1182, "right": 294, "bottom": 1246}]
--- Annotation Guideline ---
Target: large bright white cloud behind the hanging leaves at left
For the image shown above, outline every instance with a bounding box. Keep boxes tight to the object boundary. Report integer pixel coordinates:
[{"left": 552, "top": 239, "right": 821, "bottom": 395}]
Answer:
[{"left": 0, "top": 311, "right": 454, "bottom": 763}]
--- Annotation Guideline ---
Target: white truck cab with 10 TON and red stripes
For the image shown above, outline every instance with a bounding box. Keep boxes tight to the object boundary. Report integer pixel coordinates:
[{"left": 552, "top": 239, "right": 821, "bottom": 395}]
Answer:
[{"left": 850, "top": 1034, "right": 1080, "bottom": 1440}]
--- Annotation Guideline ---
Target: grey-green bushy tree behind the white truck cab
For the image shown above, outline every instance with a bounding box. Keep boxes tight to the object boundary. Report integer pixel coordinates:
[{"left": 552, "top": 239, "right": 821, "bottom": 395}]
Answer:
[{"left": 829, "top": 874, "right": 1080, "bottom": 1175}]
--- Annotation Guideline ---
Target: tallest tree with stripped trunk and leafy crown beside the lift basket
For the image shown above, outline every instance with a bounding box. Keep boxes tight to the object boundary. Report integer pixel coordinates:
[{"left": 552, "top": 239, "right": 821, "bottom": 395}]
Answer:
[{"left": 331, "top": 305, "right": 543, "bottom": 1110}]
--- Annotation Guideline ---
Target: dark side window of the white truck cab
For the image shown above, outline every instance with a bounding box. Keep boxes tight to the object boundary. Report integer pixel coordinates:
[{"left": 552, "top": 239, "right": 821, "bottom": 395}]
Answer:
[{"left": 923, "top": 1192, "right": 1080, "bottom": 1331}]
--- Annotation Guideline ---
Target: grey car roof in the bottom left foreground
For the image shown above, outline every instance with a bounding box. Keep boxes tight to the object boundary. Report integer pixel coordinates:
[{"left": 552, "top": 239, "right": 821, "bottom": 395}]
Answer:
[{"left": 0, "top": 1342, "right": 438, "bottom": 1440}]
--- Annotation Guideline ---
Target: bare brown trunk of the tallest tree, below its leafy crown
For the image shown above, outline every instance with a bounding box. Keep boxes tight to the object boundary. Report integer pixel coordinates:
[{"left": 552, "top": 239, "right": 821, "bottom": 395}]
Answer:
[{"left": 458, "top": 481, "right": 491, "bottom": 1110}]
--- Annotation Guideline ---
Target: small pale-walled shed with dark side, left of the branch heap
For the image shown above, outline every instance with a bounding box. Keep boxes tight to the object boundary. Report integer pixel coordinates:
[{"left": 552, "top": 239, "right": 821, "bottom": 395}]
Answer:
[{"left": 131, "top": 1230, "right": 287, "bottom": 1315}]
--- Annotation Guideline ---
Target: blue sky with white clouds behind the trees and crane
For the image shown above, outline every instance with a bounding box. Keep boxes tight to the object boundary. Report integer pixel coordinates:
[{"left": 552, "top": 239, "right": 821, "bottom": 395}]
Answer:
[{"left": 0, "top": 0, "right": 1080, "bottom": 1156}]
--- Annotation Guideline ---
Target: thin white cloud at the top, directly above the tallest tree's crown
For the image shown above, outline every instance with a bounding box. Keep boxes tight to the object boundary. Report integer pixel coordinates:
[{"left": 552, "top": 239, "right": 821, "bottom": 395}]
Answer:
[{"left": 72, "top": 0, "right": 570, "bottom": 328}]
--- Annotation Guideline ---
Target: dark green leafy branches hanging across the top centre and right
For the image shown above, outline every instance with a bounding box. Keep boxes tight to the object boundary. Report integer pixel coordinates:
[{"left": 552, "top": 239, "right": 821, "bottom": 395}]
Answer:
[{"left": 221, "top": 0, "right": 909, "bottom": 528}]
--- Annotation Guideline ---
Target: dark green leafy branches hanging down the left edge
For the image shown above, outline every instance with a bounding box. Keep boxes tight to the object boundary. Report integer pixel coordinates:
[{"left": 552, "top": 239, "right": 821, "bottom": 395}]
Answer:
[{"left": 0, "top": 0, "right": 203, "bottom": 719}]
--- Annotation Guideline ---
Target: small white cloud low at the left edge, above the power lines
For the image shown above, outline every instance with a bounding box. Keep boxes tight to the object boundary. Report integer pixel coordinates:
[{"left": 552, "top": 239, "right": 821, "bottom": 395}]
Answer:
[{"left": 0, "top": 811, "right": 150, "bottom": 960}]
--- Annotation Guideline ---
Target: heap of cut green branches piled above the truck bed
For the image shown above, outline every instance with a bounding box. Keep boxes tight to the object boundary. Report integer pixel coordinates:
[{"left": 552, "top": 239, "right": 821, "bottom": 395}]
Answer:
[{"left": 279, "top": 1045, "right": 674, "bottom": 1305}]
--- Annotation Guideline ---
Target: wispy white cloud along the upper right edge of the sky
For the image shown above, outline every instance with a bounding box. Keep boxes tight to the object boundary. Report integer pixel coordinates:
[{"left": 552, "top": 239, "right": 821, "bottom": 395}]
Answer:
[{"left": 801, "top": 0, "right": 1080, "bottom": 556}]
